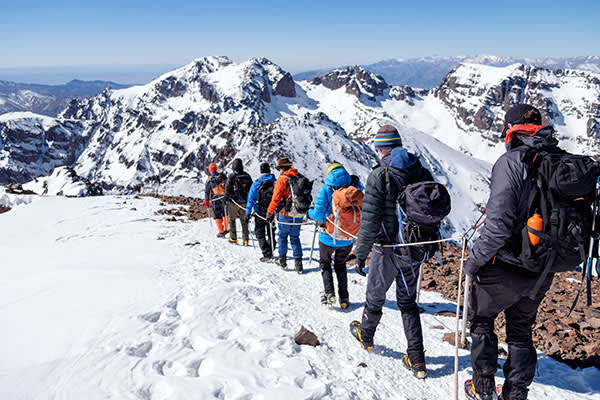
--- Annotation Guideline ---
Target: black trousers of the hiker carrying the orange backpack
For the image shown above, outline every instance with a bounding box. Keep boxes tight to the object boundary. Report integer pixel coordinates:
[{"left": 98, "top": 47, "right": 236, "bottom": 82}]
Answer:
[{"left": 319, "top": 242, "right": 352, "bottom": 300}]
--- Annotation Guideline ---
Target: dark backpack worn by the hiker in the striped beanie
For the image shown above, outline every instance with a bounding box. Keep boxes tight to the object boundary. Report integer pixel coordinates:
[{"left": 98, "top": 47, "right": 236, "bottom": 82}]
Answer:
[{"left": 388, "top": 170, "right": 452, "bottom": 264}]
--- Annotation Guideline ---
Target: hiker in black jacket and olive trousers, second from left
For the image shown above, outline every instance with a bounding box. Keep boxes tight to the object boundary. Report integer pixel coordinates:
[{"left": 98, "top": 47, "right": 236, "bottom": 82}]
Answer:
[{"left": 225, "top": 158, "right": 252, "bottom": 246}]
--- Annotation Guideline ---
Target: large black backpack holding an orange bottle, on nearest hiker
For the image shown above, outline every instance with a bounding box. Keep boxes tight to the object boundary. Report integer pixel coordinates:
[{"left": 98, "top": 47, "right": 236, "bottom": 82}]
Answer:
[{"left": 515, "top": 150, "right": 600, "bottom": 298}]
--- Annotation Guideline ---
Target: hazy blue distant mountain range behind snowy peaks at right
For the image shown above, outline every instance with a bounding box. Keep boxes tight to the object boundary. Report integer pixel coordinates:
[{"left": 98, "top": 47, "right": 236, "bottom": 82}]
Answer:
[{"left": 294, "top": 55, "right": 600, "bottom": 89}]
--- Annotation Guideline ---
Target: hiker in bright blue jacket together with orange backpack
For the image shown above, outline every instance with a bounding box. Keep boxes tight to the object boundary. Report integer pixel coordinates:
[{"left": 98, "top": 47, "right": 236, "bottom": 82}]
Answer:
[{"left": 308, "top": 161, "right": 364, "bottom": 310}]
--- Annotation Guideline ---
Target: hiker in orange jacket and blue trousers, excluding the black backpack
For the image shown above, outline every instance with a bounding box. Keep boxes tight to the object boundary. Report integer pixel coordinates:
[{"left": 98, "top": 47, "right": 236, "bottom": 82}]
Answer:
[{"left": 267, "top": 157, "right": 303, "bottom": 273}]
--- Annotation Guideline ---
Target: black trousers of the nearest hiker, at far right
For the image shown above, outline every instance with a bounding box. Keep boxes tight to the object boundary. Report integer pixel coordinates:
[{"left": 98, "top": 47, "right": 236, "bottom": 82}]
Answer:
[{"left": 468, "top": 262, "right": 553, "bottom": 400}]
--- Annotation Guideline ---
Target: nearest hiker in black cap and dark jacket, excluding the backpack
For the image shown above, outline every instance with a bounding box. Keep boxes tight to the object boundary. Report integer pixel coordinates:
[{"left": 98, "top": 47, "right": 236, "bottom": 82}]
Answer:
[{"left": 464, "top": 104, "right": 558, "bottom": 400}]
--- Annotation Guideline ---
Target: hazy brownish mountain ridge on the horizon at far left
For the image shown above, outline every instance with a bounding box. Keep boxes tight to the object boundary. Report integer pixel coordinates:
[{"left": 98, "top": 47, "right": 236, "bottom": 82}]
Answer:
[{"left": 0, "top": 79, "right": 129, "bottom": 117}]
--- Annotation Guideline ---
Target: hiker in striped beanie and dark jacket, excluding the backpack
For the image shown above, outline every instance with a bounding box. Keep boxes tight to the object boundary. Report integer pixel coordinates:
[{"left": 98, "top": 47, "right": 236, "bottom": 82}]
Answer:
[{"left": 350, "top": 125, "right": 433, "bottom": 379}]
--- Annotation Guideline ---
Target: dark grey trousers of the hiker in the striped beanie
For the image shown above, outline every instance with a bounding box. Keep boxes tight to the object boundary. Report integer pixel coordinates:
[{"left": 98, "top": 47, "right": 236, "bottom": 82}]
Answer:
[{"left": 360, "top": 246, "right": 425, "bottom": 364}]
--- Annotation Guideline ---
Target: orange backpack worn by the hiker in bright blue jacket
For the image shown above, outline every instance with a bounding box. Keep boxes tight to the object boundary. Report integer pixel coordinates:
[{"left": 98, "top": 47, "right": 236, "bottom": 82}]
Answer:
[{"left": 325, "top": 186, "right": 364, "bottom": 243}]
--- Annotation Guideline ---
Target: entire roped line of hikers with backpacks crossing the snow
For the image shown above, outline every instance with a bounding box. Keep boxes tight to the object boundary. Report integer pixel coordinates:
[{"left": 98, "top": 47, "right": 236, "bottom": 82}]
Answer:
[{"left": 205, "top": 104, "right": 600, "bottom": 400}]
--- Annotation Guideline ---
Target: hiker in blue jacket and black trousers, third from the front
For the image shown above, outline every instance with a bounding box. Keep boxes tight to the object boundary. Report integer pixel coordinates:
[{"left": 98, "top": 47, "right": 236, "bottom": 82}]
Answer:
[{"left": 246, "top": 163, "right": 275, "bottom": 262}]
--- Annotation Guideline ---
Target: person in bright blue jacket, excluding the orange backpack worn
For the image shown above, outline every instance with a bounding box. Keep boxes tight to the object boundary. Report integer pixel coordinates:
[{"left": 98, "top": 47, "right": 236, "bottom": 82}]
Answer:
[{"left": 308, "top": 161, "right": 364, "bottom": 309}]
